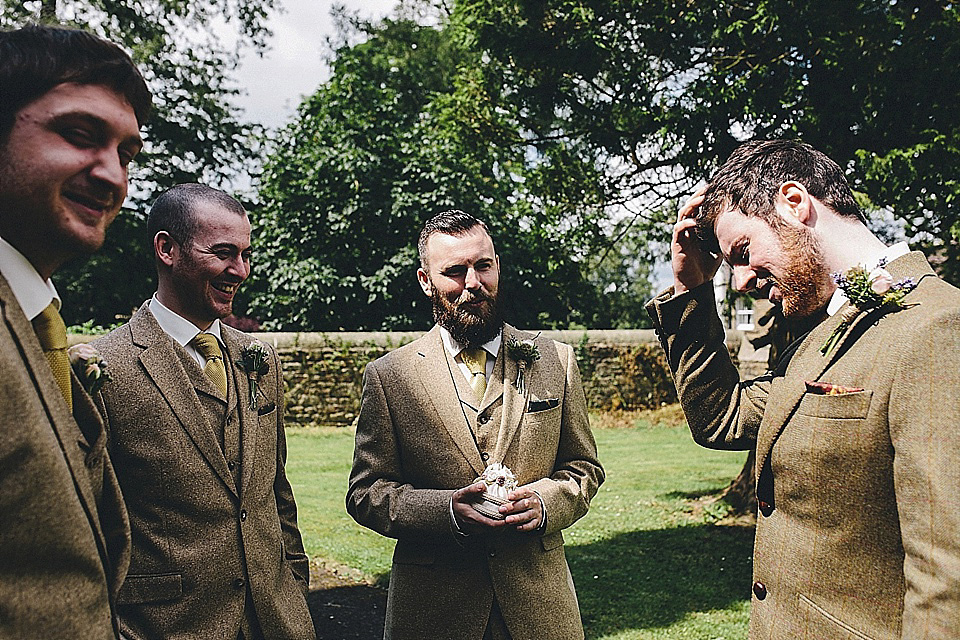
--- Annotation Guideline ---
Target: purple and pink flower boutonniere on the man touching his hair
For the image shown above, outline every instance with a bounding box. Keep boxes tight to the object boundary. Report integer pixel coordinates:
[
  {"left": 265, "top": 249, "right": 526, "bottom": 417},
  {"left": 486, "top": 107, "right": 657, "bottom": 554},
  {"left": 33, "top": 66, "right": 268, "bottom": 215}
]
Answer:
[{"left": 820, "top": 260, "right": 919, "bottom": 356}]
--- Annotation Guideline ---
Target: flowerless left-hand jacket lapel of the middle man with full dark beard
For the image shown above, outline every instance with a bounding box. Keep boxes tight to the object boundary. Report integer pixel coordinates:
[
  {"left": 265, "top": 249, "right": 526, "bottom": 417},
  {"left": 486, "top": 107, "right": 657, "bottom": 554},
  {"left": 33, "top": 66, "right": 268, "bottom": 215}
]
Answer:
[{"left": 415, "top": 325, "right": 490, "bottom": 476}]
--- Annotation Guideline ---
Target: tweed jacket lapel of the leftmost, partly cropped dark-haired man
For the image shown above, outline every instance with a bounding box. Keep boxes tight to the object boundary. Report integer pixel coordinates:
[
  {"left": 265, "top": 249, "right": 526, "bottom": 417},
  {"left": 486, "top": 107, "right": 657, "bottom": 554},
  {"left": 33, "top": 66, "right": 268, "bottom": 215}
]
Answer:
[{"left": 0, "top": 275, "right": 110, "bottom": 566}]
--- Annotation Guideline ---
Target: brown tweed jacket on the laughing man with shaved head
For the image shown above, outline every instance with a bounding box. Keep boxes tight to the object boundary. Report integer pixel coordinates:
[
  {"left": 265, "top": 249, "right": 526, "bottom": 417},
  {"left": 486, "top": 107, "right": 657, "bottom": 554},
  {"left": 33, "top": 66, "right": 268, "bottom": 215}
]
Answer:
[{"left": 93, "top": 303, "right": 315, "bottom": 640}]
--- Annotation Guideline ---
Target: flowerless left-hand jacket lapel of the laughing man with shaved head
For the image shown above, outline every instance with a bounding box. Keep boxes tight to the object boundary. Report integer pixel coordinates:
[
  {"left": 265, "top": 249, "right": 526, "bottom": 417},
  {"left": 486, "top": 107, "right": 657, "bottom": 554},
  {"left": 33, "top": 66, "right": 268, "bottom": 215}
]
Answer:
[{"left": 130, "top": 302, "right": 237, "bottom": 495}]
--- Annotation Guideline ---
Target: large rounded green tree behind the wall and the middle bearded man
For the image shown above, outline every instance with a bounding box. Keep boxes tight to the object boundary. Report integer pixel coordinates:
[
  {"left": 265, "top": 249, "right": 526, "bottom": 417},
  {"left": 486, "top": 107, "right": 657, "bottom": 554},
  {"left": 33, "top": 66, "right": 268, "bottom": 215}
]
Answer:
[{"left": 251, "top": 6, "right": 652, "bottom": 330}]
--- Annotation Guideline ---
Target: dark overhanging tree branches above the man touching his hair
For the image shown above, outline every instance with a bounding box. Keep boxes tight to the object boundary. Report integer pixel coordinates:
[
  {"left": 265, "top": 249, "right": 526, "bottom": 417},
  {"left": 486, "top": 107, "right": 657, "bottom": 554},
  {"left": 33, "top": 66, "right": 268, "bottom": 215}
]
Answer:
[{"left": 454, "top": 0, "right": 960, "bottom": 281}]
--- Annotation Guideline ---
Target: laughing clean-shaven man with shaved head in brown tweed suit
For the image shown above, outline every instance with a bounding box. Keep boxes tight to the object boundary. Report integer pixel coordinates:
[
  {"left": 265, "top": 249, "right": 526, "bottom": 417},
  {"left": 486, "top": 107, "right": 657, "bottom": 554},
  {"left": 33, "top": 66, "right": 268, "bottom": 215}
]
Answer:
[{"left": 94, "top": 184, "right": 315, "bottom": 640}]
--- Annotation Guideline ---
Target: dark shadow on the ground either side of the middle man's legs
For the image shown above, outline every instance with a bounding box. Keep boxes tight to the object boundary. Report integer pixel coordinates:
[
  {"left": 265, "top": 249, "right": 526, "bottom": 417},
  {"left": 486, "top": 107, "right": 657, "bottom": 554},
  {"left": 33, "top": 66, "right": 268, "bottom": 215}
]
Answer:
[{"left": 307, "top": 525, "right": 753, "bottom": 640}]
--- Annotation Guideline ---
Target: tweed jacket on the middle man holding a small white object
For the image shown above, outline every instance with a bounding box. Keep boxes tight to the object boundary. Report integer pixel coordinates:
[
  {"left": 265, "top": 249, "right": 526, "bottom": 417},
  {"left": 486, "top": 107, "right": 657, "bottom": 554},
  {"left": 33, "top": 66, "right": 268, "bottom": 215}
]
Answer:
[{"left": 346, "top": 326, "right": 604, "bottom": 640}]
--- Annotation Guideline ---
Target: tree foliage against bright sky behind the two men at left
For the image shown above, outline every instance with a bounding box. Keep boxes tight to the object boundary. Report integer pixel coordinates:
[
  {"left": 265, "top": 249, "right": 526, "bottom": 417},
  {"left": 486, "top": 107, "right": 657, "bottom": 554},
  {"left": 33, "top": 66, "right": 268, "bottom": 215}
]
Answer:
[{"left": 0, "top": 0, "right": 276, "bottom": 325}]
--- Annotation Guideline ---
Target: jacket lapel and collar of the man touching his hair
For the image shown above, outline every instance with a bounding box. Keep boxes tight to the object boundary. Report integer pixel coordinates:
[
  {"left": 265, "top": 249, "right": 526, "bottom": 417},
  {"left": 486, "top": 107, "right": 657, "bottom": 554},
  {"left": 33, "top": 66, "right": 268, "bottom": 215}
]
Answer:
[{"left": 756, "top": 251, "right": 934, "bottom": 473}]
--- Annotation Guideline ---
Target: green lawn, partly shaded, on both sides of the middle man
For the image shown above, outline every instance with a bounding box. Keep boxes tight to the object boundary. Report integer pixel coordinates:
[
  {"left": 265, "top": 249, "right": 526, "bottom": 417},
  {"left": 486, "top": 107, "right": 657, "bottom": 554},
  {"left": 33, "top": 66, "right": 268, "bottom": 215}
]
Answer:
[{"left": 287, "top": 407, "right": 753, "bottom": 640}]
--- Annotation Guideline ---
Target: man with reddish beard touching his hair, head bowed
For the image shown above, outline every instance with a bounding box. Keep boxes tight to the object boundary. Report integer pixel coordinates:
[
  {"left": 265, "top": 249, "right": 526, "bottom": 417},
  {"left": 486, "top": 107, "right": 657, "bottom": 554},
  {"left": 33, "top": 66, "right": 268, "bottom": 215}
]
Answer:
[{"left": 647, "top": 140, "right": 960, "bottom": 640}]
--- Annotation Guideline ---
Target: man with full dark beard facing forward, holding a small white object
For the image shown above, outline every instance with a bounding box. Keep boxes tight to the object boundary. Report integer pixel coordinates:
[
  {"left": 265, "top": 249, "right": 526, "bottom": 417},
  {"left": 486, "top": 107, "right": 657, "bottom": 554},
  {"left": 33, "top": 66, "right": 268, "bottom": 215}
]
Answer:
[{"left": 347, "top": 211, "right": 603, "bottom": 640}]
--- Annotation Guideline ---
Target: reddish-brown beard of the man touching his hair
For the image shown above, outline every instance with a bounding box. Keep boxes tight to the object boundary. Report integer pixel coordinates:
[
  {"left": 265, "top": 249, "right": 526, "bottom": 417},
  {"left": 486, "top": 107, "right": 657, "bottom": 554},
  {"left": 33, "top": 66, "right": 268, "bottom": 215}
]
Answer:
[{"left": 767, "top": 220, "right": 835, "bottom": 317}]
